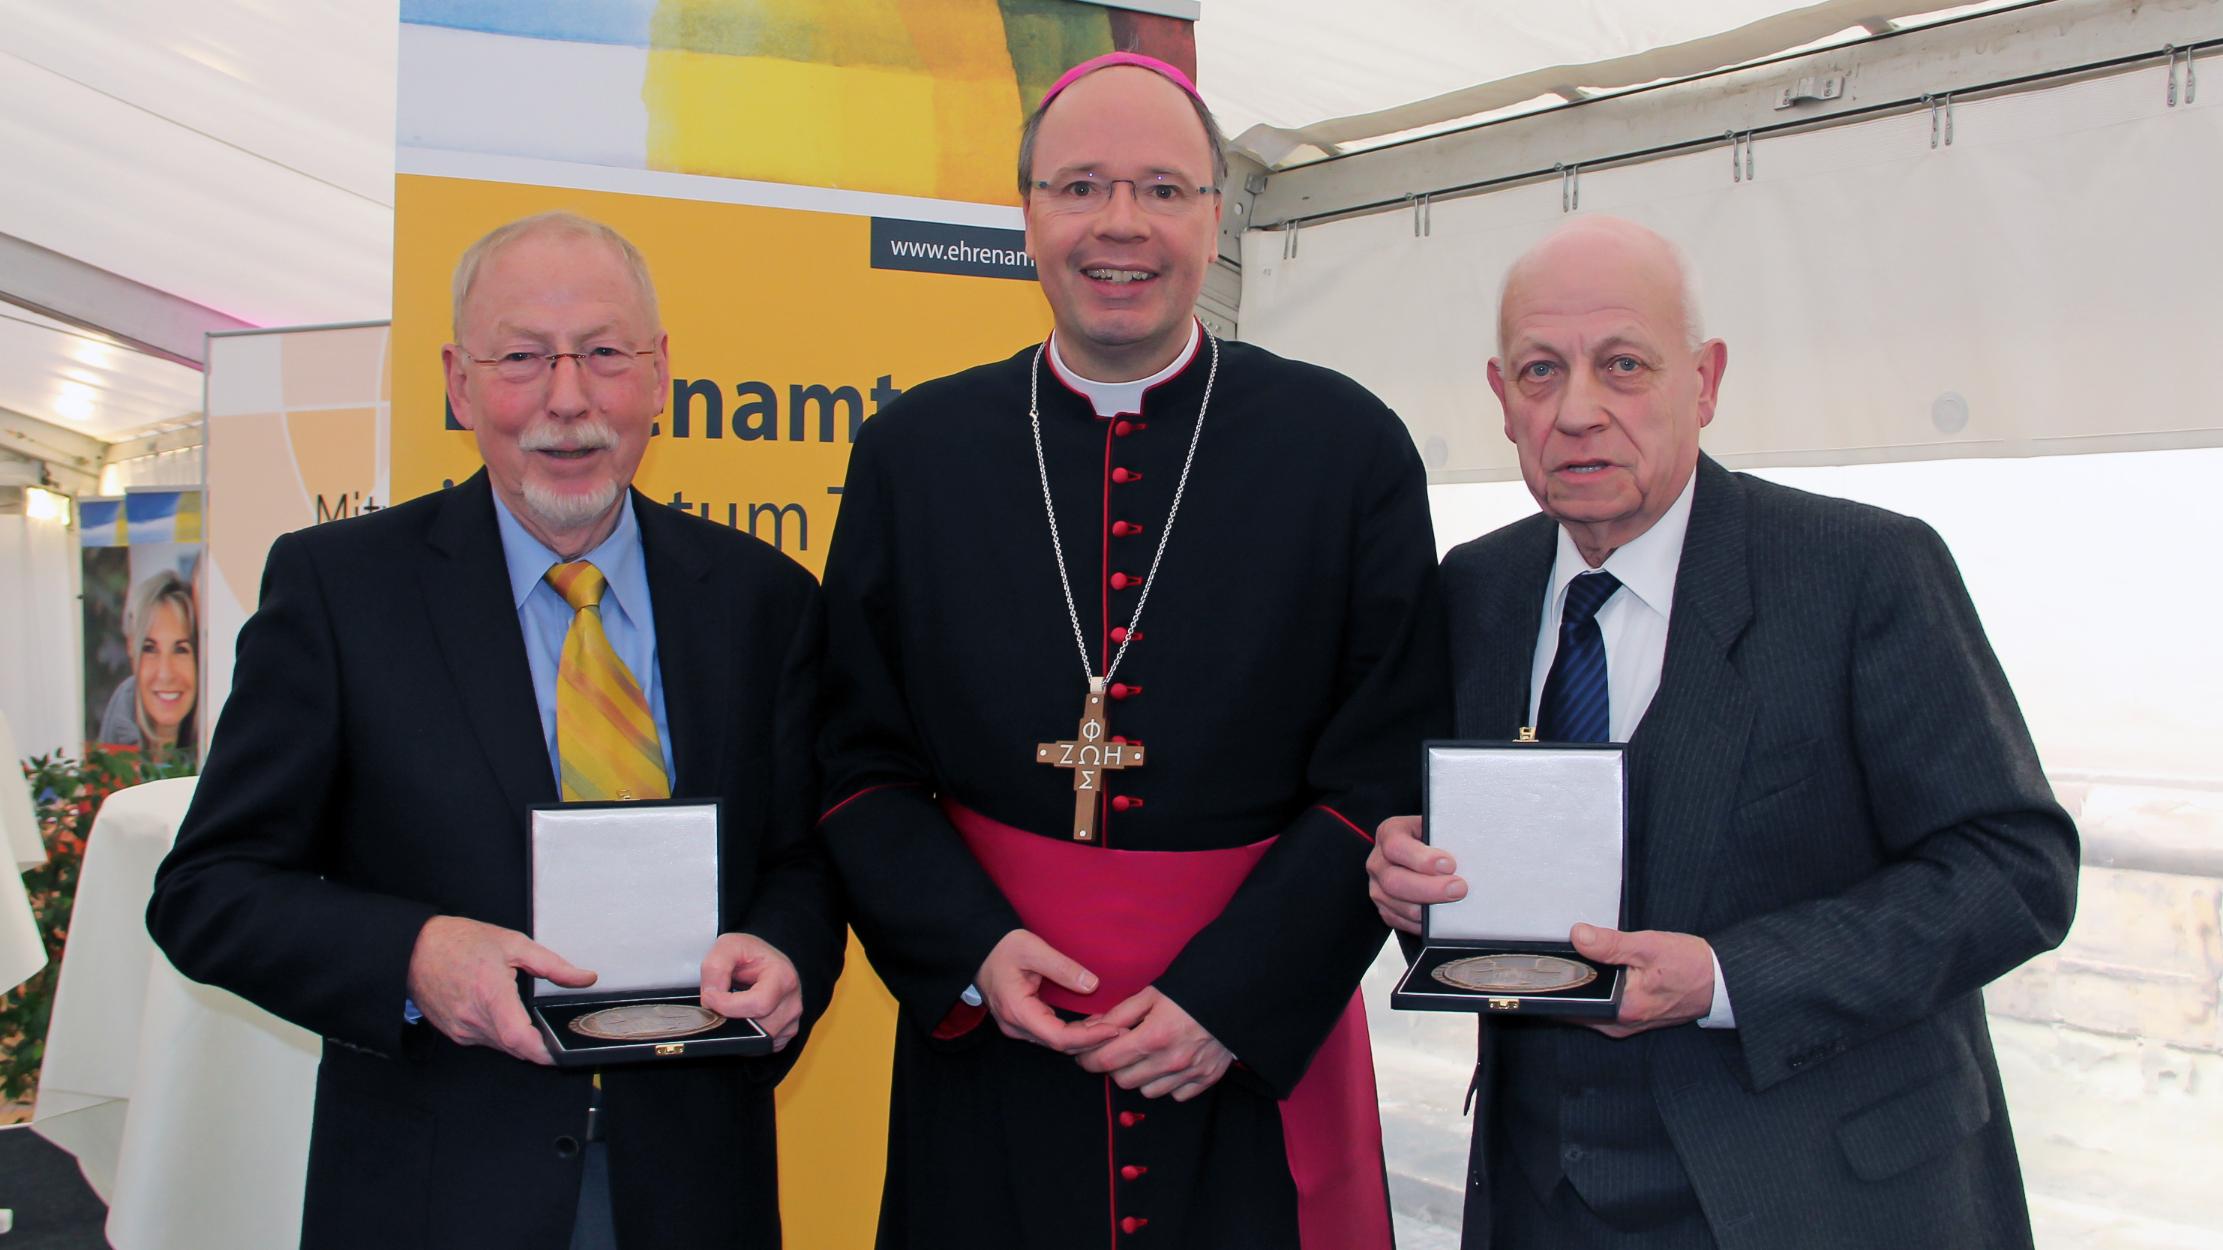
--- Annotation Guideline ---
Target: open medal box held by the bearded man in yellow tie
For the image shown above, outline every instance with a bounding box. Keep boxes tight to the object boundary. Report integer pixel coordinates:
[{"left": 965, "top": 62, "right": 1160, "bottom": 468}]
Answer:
[{"left": 525, "top": 801, "right": 771, "bottom": 1068}]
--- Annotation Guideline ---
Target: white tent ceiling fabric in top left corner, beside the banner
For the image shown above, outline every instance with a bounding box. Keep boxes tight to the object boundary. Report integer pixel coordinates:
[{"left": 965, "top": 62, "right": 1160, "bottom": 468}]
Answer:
[{"left": 0, "top": 0, "right": 398, "bottom": 331}]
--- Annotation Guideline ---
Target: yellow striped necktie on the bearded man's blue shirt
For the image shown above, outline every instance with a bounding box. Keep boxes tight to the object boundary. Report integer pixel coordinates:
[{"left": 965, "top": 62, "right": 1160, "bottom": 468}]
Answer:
[{"left": 547, "top": 560, "right": 671, "bottom": 803}]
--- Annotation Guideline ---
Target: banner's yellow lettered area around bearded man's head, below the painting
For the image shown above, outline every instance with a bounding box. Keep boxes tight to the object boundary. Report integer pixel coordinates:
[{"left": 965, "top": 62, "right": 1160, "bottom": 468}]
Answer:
[{"left": 391, "top": 176, "right": 1049, "bottom": 572}]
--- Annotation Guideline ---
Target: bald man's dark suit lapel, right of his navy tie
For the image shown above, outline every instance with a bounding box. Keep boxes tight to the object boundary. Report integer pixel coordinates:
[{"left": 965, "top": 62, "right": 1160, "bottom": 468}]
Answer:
[{"left": 1629, "top": 456, "right": 1754, "bottom": 932}]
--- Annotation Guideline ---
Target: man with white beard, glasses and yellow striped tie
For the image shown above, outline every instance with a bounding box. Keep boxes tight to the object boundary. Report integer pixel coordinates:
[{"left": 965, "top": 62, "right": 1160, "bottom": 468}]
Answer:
[{"left": 147, "top": 214, "right": 843, "bottom": 1250}]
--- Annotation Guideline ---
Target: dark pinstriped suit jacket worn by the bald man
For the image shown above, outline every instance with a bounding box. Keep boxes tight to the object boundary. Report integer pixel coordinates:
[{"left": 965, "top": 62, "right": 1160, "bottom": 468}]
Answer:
[{"left": 1443, "top": 458, "right": 2076, "bottom": 1250}]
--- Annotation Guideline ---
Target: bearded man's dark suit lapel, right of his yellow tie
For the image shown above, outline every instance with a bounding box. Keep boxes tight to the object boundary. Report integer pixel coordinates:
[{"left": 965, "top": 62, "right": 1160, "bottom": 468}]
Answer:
[{"left": 634, "top": 492, "right": 729, "bottom": 796}]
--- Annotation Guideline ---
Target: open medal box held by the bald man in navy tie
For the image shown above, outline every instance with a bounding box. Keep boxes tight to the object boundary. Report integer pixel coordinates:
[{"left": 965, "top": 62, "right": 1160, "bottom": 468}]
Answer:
[{"left": 1389, "top": 741, "right": 1629, "bottom": 1019}]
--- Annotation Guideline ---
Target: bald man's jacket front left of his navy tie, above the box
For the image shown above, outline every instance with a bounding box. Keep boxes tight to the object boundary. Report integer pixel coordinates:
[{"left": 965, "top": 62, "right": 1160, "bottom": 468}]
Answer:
[{"left": 1445, "top": 514, "right": 1558, "bottom": 738}]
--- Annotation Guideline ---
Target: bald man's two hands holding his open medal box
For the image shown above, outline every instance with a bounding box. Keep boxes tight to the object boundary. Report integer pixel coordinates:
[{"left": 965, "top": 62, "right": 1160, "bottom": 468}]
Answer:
[{"left": 1367, "top": 816, "right": 1714, "bottom": 1036}]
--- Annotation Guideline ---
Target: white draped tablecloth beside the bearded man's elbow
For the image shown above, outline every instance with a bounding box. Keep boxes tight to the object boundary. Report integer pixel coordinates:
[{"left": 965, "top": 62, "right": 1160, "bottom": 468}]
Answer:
[{"left": 31, "top": 776, "right": 318, "bottom": 1250}]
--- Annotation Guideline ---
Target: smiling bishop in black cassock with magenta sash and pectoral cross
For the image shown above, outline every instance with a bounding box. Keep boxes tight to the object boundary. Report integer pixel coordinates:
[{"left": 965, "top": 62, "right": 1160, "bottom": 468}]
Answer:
[{"left": 820, "top": 53, "right": 1447, "bottom": 1250}]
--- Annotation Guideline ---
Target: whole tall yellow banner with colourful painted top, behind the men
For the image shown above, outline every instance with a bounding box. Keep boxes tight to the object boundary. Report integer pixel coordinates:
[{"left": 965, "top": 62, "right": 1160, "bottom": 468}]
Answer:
[{"left": 400, "top": 0, "right": 1194, "bottom": 1250}]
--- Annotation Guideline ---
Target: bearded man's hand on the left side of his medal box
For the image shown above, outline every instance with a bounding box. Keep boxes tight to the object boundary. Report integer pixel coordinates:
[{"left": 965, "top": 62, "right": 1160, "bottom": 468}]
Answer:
[{"left": 409, "top": 916, "right": 594, "bottom": 1065}]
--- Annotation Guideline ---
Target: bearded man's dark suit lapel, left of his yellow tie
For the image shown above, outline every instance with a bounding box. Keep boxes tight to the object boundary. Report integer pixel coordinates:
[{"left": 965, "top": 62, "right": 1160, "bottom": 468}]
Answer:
[{"left": 420, "top": 469, "right": 556, "bottom": 814}]
